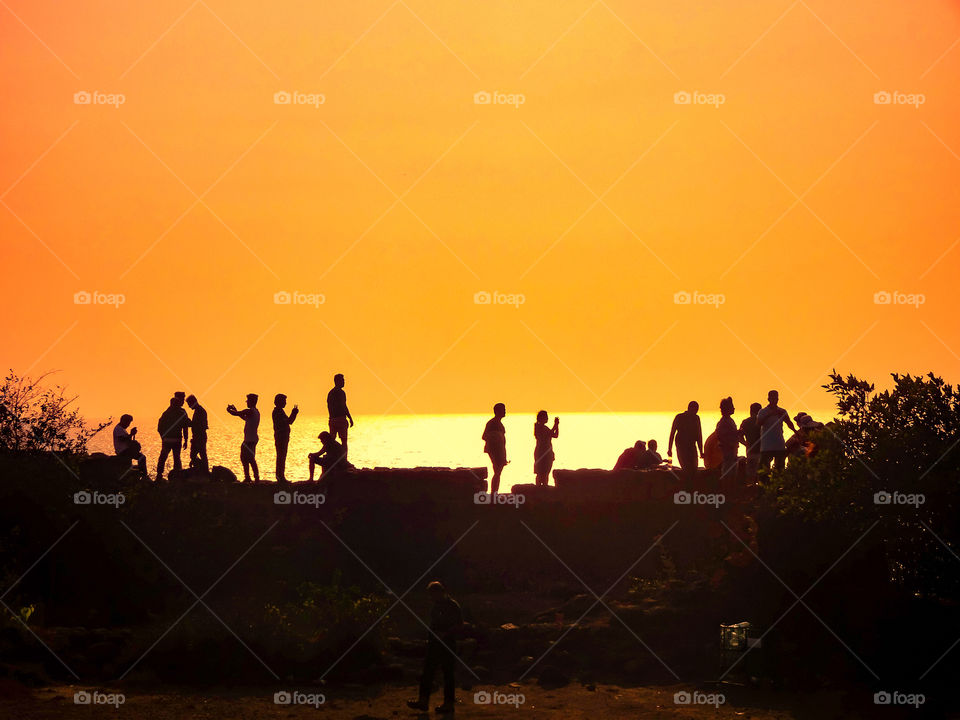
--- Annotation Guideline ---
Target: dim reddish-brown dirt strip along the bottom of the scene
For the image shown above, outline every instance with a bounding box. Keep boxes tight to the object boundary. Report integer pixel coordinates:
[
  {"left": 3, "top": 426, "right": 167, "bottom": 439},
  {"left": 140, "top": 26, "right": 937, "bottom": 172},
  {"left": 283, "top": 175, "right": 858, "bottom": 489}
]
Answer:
[{"left": 0, "top": 683, "right": 936, "bottom": 720}]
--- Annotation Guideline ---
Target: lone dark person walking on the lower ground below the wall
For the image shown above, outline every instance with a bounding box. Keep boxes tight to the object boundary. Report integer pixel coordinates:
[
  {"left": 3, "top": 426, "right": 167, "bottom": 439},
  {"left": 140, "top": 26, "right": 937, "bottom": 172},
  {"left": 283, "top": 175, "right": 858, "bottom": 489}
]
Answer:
[{"left": 407, "top": 580, "right": 463, "bottom": 713}]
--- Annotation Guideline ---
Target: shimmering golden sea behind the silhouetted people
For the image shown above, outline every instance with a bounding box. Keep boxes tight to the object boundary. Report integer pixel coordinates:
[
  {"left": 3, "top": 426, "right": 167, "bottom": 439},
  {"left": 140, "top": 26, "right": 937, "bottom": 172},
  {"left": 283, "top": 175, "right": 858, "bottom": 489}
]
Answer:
[{"left": 90, "top": 409, "right": 826, "bottom": 480}]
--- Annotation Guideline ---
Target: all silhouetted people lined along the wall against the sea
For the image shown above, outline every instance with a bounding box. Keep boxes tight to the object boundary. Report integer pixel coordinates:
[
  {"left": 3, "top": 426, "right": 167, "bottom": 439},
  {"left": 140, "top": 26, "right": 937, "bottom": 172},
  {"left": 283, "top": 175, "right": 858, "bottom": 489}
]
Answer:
[{"left": 113, "top": 386, "right": 823, "bottom": 486}]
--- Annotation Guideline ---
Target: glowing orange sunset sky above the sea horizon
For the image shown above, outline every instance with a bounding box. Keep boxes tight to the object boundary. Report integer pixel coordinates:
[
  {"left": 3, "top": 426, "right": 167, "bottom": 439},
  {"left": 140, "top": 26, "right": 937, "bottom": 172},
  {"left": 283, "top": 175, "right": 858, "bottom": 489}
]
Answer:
[{"left": 0, "top": 0, "right": 960, "bottom": 416}]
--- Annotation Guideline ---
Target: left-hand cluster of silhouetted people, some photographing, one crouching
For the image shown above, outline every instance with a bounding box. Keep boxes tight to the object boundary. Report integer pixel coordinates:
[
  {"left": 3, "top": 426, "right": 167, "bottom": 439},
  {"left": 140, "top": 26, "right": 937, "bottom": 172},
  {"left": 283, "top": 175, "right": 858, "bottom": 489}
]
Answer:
[{"left": 113, "top": 373, "right": 353, "bottom": 482}]
